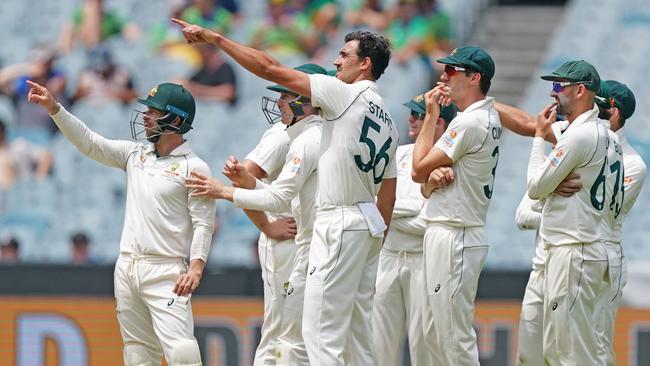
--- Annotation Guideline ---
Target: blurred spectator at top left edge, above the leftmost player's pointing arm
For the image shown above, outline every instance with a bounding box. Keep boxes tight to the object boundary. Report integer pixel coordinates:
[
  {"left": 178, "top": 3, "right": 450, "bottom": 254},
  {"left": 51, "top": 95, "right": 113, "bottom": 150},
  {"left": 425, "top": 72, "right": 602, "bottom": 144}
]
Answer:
[{"left": 58, "top": 0, "right": 140, "bottom": 53}]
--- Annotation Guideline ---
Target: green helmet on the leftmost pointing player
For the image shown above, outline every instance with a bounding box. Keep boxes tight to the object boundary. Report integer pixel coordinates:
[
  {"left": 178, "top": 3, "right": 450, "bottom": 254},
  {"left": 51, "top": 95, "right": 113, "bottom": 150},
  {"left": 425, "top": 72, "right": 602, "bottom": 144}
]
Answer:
[{"left": 138, "top": 83, "right": 196, "bottom": 123}]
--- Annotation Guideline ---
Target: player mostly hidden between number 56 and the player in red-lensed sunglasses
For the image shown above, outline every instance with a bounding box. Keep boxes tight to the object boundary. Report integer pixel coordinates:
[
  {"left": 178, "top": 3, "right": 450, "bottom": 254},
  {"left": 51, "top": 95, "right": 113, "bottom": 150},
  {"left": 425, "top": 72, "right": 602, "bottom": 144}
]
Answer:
[{"left": 372, "top": 94, "right": 456, "bottom": 366}]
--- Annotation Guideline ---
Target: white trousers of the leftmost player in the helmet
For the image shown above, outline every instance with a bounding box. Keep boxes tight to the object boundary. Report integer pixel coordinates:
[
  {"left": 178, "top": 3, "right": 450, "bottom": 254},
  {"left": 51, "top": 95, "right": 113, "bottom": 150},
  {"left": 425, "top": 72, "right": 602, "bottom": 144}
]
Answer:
[{"left": 114, "top": 254, "right": 201, "bottom": 366}]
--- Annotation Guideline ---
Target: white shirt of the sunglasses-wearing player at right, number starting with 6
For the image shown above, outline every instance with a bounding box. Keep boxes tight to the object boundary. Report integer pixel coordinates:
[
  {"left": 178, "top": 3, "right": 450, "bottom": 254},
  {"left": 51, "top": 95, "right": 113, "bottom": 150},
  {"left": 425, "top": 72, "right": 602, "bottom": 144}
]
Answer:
[{"left": 528, "top": 107, "right": 608, "bottom": 245}]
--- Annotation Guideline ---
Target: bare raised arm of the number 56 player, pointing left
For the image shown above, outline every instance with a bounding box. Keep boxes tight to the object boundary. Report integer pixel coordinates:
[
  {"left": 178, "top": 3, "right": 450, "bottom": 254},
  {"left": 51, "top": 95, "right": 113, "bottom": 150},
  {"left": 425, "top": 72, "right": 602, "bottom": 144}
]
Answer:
[{"left": 172, "top": 18, "right": 311, "bottom": 96}]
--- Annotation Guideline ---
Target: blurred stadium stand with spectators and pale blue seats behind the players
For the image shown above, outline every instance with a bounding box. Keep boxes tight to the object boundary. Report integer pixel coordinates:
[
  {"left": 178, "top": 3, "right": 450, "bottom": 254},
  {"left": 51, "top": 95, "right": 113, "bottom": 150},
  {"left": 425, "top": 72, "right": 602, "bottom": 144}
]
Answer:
[{"left": 0, "top": 0, "right": 650, "bottom": 269}]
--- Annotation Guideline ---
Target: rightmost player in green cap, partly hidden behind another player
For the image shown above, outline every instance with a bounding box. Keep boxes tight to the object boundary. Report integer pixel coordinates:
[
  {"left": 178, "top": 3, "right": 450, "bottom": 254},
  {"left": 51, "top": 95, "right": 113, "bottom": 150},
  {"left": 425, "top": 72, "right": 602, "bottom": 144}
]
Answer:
[{"left": 596, "top": 80, "right": 646, "bottom": 365}]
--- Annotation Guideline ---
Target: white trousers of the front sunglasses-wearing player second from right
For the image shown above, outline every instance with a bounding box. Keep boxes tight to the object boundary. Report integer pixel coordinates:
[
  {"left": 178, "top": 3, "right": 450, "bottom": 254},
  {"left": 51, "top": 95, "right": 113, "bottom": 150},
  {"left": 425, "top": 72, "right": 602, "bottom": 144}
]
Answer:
[{"left": 544, "top": 243, "right": 611, "bottom": 366}]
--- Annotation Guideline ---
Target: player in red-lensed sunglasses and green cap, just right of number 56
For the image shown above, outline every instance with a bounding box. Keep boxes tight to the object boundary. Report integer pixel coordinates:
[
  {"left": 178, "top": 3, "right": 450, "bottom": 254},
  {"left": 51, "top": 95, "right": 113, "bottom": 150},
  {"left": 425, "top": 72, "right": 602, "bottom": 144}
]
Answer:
[{"left": 412, "top": 47, "right": 501, "bottom": 365}]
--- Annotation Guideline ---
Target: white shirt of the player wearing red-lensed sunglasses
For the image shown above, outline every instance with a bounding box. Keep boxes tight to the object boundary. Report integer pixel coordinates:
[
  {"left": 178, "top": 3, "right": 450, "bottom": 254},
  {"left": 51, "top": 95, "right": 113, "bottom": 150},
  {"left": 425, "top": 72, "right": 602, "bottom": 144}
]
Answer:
[{"left": 422, "top": 97, "right": 501, "bottom": 227}]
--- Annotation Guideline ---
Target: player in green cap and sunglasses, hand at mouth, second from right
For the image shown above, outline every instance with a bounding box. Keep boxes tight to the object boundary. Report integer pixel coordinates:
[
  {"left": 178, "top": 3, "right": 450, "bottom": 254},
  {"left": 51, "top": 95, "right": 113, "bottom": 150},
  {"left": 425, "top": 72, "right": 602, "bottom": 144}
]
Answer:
[{"left": 528, "top": 60, "right": 609, "bottom": 365}]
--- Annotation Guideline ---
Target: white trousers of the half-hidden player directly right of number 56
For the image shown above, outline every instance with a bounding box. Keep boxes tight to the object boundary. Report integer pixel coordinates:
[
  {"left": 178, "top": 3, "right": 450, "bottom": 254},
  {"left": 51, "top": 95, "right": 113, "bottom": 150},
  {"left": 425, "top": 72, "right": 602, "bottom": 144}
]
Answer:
[{"left": 372, "top": 246, "right": 433, "bottom": 366}]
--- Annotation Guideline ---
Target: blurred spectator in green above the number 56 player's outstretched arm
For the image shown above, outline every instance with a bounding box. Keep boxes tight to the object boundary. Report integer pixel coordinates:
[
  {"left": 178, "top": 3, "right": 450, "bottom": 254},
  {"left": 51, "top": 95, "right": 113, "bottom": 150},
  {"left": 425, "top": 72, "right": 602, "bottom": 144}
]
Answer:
[{"left": 251, "top": 0, "right": 319, "bottom": 57}]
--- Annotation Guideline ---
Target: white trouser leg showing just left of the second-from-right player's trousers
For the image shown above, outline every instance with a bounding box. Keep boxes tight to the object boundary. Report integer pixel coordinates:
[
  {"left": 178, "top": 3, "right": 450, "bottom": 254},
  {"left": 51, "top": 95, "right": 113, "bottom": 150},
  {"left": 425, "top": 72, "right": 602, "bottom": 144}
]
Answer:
[{"left": 517, "top": 268, "right": 544, "bottom": 366}]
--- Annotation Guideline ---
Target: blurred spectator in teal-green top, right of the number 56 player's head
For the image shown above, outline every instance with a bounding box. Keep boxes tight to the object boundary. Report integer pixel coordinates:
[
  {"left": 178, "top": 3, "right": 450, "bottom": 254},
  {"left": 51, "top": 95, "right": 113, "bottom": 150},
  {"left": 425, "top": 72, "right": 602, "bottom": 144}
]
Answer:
[{"left": 386, "top": 0, "right": 428, "bottom": 65}]
